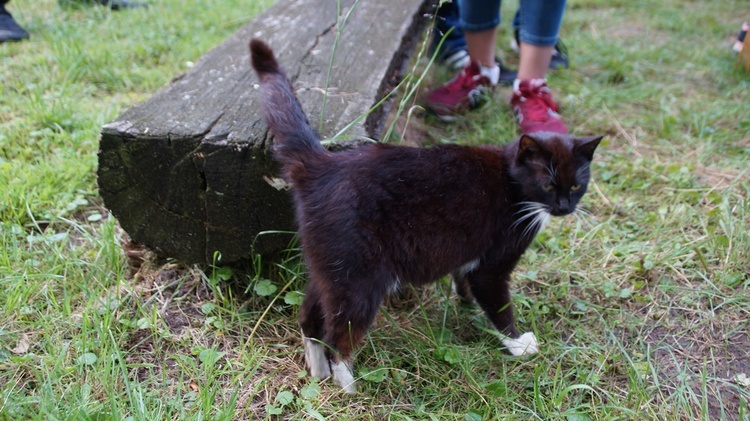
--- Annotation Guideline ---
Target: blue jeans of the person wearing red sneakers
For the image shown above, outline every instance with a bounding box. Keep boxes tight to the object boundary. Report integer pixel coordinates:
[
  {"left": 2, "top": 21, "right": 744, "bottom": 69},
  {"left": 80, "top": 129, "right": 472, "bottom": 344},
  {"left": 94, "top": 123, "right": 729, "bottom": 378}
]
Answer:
[{"left": 462, "top": 0, "right": 566, "bottom": 47}]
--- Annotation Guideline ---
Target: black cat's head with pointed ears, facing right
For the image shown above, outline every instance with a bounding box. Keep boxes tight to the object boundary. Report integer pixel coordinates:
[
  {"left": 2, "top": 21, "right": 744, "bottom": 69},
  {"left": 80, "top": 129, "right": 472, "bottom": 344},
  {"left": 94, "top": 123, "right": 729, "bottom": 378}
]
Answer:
[{"left": 510, "top": 132, "right": 602, "bottom": 216}]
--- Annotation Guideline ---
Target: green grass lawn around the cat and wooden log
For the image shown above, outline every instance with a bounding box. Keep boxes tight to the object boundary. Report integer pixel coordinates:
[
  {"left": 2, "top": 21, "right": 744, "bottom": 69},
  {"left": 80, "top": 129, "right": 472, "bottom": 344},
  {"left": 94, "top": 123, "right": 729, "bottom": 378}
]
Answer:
[{"left": 0, "top": 0, "right": 750, "bottom": 420}]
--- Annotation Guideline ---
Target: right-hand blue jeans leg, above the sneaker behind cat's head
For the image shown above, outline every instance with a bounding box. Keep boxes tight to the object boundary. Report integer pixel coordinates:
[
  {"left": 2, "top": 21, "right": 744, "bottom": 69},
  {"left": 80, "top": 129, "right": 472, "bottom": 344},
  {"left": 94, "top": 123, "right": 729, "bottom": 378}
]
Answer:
[{"left": 518, "top": 0, "right": 566, "bottom": 47}]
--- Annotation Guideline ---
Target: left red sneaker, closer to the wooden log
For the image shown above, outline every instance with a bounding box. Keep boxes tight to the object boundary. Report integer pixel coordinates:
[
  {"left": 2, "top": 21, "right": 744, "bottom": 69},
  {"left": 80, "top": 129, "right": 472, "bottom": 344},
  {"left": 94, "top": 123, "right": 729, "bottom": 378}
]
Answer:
[{"left": 425, "top": 61, "right": 500, "bottom": 121}]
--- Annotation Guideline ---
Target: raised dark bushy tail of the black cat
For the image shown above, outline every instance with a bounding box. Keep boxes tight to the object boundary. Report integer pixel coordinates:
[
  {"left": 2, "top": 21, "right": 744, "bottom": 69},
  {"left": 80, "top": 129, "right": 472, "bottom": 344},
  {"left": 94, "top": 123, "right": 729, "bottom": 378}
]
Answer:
[{"left": 250, "top": 39, "right": 326, "bottom": 176}]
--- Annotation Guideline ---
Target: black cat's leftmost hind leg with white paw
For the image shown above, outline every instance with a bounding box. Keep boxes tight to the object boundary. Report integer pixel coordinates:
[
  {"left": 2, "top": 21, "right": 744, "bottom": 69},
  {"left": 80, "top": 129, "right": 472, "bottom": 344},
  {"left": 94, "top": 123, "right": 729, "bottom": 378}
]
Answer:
[{"left": 299, "top": 279, "right": 331, "bottom": 379}]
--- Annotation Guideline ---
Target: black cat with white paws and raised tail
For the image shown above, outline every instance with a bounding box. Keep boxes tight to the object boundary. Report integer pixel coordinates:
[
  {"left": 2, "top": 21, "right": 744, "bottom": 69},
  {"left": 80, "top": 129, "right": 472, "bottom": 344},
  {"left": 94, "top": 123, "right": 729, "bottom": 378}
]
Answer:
[{"left": 250, "top": 39, "right": 601, "bottom": 393}]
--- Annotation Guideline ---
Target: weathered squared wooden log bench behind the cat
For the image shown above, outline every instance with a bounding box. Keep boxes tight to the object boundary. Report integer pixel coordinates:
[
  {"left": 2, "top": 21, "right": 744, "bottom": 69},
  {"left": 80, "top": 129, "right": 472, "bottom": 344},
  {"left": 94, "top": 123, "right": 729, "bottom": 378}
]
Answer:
[{"left": 98, "top": 0, "right": 432, "bottom": 263}]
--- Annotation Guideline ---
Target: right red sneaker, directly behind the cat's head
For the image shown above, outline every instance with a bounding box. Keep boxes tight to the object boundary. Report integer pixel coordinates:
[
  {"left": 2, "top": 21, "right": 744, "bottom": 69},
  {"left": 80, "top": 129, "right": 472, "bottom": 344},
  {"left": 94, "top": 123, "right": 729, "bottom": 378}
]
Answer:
[{"left": 510, "top": 79, "right": 568, "bottom": 134}]
